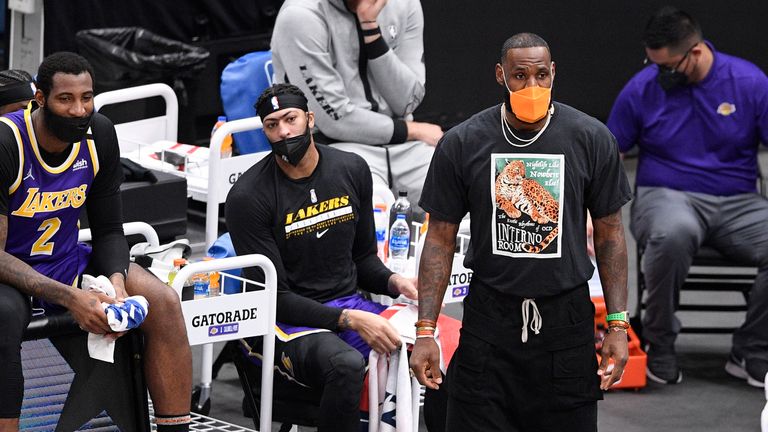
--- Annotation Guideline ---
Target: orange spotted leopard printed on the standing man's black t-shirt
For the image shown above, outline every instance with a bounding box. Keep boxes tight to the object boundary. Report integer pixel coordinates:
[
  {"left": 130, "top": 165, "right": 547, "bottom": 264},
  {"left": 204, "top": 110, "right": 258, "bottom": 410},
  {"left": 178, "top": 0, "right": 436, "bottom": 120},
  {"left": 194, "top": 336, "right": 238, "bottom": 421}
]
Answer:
[{"left": 496, "top": 160, "right": 560, "bottom": 253}]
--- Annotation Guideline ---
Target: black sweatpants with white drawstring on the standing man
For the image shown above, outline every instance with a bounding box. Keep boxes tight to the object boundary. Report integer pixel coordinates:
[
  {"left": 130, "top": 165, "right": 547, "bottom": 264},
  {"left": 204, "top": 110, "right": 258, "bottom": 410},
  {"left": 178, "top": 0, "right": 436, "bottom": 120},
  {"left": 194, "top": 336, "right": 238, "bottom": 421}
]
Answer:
[{"left": 446, "top": 284, "right": 602, "bottom": 432}]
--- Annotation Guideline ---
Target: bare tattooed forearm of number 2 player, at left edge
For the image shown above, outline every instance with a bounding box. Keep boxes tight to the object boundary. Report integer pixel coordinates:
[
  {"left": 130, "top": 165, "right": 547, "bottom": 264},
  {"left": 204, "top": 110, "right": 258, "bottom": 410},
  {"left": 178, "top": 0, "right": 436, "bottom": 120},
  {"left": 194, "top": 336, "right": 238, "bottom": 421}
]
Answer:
[{"left": 0, "top": 215, "right": 72, "bottom": 306}]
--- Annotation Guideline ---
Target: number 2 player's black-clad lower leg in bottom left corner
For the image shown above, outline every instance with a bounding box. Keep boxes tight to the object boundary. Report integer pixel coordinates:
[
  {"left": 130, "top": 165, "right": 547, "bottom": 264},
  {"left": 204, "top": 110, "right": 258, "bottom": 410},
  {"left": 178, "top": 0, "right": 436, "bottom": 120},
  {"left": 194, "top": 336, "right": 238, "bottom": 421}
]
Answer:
[{"left": 0, "top": 284, "right": 32, "bottom": 418}]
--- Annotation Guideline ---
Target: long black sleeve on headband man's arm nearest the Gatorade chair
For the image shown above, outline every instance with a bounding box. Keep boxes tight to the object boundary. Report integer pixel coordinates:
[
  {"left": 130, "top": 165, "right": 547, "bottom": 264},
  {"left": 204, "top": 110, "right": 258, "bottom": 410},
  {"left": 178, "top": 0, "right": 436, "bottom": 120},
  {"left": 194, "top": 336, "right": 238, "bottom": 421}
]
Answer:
[{"left": 225, "top": 177, "right": 342, "bottom": 331}]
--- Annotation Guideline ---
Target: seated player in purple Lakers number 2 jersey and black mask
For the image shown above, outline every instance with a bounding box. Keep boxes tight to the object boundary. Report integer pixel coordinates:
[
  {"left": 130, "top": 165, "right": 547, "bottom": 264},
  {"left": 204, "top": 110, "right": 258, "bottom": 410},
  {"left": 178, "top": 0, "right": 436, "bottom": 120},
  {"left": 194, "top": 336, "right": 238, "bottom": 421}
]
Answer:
[{"left": 0, "top": 52, "right": 192, "bottom": 432}]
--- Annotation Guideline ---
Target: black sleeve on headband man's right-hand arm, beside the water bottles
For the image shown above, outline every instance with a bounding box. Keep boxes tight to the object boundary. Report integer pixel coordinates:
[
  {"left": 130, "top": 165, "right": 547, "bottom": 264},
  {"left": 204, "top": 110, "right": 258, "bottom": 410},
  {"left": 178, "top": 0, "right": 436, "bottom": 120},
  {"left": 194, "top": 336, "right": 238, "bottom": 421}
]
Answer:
[{"left": 352, "top": 160, "right": 392, "bottom": 296}]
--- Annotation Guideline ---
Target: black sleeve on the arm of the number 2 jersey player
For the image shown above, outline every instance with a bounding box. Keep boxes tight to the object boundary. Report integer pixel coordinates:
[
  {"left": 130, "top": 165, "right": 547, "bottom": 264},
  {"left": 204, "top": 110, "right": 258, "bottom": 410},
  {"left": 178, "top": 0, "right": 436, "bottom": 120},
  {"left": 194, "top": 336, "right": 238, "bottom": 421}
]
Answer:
[{"left": 86, "top": 113, "right": 130, "bottom": 276}]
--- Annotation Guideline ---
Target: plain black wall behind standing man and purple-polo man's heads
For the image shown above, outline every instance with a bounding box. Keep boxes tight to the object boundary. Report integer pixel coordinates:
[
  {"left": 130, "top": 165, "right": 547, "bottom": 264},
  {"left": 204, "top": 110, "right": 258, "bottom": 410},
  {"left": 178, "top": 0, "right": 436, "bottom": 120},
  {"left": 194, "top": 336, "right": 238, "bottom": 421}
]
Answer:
[{"left": 417, "top": 0, "right": 768, "bottom": 125}]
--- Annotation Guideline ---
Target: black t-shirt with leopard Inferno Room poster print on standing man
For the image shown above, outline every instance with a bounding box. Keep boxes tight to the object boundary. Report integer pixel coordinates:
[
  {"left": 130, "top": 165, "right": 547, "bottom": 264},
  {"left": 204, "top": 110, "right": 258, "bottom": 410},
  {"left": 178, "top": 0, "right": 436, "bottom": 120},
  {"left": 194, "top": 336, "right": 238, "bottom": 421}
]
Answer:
[{"left": 420, "top": 103, "right": 632, "bottom": 297}]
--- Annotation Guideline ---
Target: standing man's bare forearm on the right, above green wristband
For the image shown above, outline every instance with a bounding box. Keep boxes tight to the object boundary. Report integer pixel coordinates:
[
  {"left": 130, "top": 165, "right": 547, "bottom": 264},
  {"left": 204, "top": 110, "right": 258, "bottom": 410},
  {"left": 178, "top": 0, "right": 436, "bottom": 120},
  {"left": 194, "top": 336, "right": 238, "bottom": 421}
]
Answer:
[{"left": 594, "top": 210, "right": 627, "bottom": 313}]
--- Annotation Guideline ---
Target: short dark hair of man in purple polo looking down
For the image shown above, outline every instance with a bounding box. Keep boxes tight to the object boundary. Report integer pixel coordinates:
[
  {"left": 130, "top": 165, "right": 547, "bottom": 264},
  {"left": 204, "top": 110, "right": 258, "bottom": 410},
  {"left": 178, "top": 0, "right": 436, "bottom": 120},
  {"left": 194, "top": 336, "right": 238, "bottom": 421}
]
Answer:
[{"left": 643, "top": 6, "right": 703, "bottom": 53}]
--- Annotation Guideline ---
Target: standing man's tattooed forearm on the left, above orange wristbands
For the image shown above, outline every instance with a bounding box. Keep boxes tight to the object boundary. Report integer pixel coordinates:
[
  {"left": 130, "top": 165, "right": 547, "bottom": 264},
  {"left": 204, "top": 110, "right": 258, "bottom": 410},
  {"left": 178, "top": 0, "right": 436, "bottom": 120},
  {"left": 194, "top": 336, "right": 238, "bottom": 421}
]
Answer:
[{"left": 419, "top": 220, "right": 459, "bottom": 320}]
